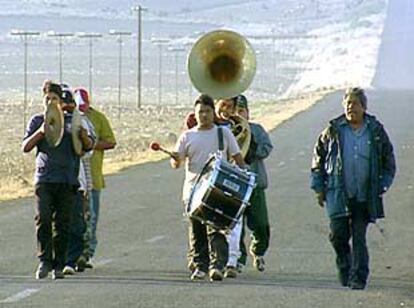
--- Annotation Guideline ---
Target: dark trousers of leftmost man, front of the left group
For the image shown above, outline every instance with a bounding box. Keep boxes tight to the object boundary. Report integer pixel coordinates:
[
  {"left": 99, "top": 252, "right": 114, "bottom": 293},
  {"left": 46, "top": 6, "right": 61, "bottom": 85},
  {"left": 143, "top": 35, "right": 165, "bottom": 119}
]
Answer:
[{"left": 35, "top": 183, "right": 76, "bottom": 269}]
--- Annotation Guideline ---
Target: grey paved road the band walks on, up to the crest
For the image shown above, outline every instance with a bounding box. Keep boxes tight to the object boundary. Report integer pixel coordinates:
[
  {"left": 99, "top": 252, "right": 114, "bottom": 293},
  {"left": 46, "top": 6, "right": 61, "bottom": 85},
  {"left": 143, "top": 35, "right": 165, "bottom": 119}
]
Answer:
[{"left": 0, "top": 92, "right": 414, "bottom": 308}]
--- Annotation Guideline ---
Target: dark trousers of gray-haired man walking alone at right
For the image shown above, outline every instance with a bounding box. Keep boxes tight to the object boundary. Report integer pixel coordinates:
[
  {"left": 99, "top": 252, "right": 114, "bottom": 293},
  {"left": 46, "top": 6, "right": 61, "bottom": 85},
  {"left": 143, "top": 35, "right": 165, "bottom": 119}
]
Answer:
[{"left": 329, "top": 199, "right": 369, "bottom": 283}]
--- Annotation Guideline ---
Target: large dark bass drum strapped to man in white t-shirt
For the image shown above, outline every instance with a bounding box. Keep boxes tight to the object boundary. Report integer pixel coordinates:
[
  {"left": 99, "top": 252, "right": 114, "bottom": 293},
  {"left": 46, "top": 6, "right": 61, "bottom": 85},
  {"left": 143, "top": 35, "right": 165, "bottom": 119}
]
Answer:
[{"left": 186, "top": 155, "right": 256, "bottom": 231}]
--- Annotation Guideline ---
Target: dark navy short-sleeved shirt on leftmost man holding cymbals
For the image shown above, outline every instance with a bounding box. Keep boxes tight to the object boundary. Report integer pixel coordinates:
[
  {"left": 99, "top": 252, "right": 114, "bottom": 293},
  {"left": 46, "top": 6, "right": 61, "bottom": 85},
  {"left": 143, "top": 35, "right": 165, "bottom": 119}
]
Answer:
[{"left": 23, "top": 113, "right": 79, "bottom": 186}]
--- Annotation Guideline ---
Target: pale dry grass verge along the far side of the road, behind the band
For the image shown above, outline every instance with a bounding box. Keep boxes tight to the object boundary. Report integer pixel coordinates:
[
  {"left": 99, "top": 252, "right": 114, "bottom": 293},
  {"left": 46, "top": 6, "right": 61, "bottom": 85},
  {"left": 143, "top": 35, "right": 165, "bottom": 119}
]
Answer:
[{"left": 0, "top": 91, "right": 328, "bottom": 201}]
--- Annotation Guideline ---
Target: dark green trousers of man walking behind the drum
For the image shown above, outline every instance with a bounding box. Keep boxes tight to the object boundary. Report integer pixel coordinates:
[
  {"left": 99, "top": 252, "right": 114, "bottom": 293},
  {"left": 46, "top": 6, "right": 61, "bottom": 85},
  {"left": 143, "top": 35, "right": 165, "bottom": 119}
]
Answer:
[{"left": 239, "top": 188, "right": 270, "bottom": 265}]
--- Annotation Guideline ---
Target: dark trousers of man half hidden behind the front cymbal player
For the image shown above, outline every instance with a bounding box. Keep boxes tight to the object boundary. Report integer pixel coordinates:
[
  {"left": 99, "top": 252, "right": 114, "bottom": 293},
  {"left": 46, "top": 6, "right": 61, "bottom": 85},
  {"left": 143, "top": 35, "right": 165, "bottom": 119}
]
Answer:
[{"left": 66, "top": 191, "right": 89, "bottom": 267}]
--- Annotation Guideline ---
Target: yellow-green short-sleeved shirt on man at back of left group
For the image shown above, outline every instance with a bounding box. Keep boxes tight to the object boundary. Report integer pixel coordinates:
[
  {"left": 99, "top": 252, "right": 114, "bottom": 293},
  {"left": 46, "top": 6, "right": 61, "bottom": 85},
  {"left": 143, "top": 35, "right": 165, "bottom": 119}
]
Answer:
[{"left": 86, "top": 107, "right": 116, "bottom": 190}]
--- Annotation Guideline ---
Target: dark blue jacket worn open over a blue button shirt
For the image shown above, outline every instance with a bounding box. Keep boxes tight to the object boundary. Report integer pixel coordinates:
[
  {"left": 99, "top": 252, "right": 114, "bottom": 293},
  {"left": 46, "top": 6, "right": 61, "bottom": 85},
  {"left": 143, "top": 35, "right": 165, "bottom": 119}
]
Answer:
[{"left": 311, "top": 114, "right": 396, "bottom": 222}]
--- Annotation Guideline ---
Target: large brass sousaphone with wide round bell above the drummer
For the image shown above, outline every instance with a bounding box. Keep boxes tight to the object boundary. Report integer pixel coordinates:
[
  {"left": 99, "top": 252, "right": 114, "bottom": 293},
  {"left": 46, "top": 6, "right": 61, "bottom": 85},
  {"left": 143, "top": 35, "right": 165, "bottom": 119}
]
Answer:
[{"left": 187, "top": 30, "right": 256, "bottom": 158}]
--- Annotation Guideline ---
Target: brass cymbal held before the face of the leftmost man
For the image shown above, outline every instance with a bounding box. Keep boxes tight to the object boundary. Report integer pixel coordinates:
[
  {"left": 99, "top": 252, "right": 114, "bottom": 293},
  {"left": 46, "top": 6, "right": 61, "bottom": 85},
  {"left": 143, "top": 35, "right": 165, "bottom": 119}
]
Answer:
[{"left": 45, "top": 103, "right": 65, "bottom": 147}]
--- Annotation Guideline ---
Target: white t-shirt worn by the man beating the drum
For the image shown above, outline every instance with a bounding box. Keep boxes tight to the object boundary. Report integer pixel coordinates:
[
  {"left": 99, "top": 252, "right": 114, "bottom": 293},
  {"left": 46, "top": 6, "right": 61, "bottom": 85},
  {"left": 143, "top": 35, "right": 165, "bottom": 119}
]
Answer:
[{"left": 174, "top": 125, "right": 240, "bottom": 202}]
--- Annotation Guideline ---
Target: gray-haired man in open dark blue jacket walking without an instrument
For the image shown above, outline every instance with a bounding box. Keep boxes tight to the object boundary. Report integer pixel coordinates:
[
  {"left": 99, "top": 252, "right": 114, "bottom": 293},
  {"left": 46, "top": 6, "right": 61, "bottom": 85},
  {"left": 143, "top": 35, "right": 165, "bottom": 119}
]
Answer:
[{"left": 311, "top": 88, "right": 396, "bottom": 290}]
